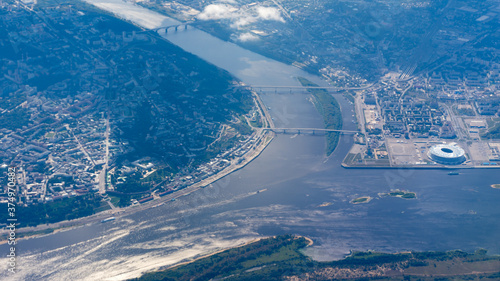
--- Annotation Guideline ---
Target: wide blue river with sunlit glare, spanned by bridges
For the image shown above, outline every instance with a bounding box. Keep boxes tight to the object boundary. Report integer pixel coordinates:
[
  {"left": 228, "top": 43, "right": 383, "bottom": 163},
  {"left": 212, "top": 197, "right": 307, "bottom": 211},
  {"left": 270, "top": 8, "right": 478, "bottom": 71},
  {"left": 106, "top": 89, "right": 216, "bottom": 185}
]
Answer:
[{"left": 0, "top": 0, "right": 500, "bottom": 280}]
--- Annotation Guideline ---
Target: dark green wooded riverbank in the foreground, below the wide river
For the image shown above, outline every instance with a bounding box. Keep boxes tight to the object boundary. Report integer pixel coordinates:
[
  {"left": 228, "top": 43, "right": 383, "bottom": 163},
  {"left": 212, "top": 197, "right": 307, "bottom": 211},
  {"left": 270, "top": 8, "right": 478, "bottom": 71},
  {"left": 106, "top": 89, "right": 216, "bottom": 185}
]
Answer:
[{"left": 133, "top": 235, "right": 500, "bottom": 281}]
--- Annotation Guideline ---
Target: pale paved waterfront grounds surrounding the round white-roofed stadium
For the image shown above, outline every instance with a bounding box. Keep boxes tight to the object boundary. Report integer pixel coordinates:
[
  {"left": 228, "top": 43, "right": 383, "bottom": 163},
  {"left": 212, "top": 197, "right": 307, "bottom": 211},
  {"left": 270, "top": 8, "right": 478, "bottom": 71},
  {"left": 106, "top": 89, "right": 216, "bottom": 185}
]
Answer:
[{"left": 342, "top": 137, "right": 500, "bottom": 169}]
